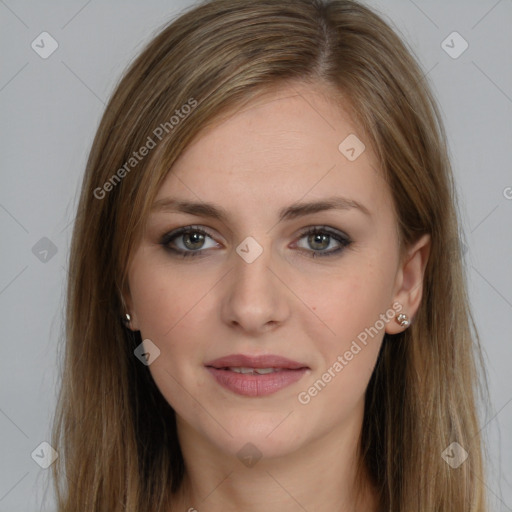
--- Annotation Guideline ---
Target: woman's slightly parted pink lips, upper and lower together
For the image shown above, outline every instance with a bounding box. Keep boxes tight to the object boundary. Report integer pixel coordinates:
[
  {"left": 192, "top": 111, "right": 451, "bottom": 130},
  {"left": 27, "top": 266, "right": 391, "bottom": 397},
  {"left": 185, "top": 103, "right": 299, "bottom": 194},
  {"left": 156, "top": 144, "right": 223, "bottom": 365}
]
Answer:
[{"left": 205, "top": 354, "right": 309, "bottom": 396}]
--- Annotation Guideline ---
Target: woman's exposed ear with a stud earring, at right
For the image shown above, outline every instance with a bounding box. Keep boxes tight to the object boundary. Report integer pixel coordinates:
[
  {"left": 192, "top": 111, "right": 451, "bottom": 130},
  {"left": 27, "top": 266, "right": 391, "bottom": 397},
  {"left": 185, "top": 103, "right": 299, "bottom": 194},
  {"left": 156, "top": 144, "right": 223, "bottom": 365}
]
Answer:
[{"left": 386, "top": 234, "right": 431, "bottom": 334}]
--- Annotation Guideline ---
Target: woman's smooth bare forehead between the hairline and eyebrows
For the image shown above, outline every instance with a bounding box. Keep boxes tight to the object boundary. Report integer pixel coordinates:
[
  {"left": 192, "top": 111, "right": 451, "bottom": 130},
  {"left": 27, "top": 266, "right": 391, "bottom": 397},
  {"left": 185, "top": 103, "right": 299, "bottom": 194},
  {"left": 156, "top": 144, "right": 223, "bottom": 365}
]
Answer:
[{"left": 155, "top": 84, "right": 389, "bottom": 222}]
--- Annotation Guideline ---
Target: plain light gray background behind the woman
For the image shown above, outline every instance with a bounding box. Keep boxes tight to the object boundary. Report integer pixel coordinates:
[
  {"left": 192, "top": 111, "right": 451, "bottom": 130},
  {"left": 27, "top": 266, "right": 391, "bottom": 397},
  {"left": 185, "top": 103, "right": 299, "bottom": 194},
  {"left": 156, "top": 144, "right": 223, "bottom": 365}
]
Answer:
[{"left": 0, "top": 0, "right": 512, "bottom": 512}]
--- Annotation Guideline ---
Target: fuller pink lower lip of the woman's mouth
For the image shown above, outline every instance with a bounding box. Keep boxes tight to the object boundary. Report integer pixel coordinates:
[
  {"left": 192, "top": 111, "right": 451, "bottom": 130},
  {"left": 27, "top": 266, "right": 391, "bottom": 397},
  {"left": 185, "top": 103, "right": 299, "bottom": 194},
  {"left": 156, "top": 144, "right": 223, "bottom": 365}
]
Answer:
[{"left": 207, "top": 367, "right": 307, "bottom": 396}]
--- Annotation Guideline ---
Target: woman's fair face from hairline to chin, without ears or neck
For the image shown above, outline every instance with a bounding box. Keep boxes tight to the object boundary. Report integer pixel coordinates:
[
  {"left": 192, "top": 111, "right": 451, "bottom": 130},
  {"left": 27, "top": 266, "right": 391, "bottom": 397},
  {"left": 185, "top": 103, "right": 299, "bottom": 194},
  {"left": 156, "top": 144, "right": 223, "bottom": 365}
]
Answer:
[{"left": 126, "top": 85, "right": 420, "bottom": 457}]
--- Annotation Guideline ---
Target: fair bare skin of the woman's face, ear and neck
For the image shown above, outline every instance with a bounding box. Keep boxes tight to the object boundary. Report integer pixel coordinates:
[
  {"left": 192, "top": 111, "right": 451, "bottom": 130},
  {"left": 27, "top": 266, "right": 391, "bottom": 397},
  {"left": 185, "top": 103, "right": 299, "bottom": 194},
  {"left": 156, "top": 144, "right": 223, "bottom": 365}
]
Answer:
[{"left": 125, "top": 84, "right": 430, "bottom": 512}]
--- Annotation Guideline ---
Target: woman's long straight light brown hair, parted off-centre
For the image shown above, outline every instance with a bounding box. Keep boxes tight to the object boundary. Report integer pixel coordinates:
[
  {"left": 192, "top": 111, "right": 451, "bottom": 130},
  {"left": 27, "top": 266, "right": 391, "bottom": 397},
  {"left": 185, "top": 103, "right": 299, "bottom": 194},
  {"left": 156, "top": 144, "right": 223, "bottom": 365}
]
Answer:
[{"left": 52, "top": 0, "right": 487, "bottom": 512}]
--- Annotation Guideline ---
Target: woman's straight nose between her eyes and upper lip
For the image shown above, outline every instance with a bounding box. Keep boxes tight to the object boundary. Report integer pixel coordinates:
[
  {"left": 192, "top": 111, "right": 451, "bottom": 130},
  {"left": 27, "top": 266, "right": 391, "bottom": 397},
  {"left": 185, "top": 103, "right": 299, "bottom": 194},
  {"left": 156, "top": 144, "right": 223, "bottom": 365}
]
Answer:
[{"left": 221, "top": 237, "right": 291, "bottom": 335}]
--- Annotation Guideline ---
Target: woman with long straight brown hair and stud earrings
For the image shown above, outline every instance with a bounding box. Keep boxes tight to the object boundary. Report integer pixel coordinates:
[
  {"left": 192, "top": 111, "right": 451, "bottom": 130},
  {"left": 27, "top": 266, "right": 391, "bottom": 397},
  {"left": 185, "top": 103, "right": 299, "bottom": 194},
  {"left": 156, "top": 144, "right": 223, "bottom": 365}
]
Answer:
[{"left": 53, "top": 0, "right": 486, "bottom": 512}]
